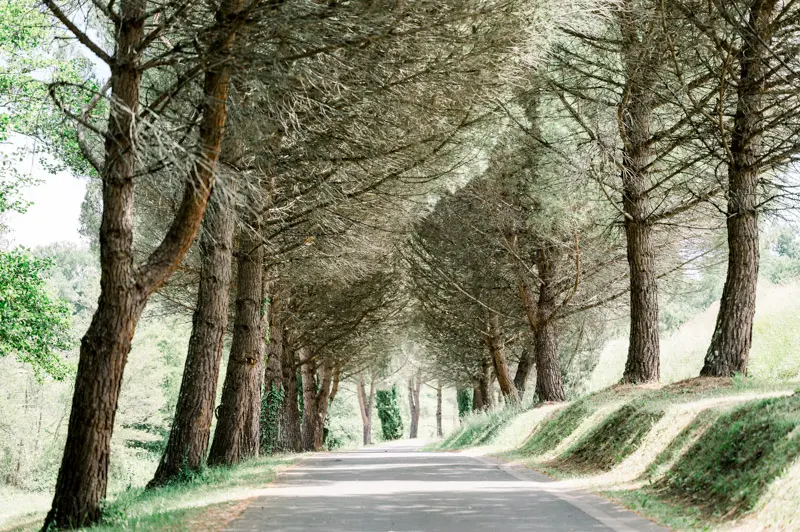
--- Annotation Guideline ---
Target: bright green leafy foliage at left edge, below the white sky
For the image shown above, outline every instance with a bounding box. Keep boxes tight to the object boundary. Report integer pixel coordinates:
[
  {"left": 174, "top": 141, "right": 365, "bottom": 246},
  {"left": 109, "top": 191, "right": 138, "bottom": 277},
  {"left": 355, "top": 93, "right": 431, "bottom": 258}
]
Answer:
[{"left": 0, "top": 250, "right": 72, "bottom": 380}]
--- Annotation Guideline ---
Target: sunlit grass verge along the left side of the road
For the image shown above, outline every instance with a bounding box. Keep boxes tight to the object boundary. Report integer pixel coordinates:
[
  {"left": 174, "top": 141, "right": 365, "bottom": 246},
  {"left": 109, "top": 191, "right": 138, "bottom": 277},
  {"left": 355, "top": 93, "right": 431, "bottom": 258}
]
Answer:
[{"left": 0, "top": 456, "right": 299, "bottom": 532}]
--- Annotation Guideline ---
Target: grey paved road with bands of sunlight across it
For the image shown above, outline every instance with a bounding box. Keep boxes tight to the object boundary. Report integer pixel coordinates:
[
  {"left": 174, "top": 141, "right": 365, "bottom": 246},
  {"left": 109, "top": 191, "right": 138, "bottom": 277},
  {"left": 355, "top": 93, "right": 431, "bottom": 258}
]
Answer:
[{"left": 228, "top": 444, "right": 665, "bottom": 532}]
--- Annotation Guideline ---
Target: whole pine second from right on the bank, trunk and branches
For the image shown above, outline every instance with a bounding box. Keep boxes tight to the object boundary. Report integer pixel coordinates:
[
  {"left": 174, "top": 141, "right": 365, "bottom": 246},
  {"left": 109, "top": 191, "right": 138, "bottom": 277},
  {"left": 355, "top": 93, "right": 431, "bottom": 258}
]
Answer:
[{"left": 548, "top": 0, "right": 719, "bottom": 384}]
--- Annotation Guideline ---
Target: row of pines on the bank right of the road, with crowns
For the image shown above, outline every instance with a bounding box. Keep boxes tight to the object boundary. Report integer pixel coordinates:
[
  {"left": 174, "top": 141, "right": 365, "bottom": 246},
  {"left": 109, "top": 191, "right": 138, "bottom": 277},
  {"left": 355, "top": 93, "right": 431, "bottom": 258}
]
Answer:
[{"left": 408, "top": 0, "right": 800, "bottom": 406}]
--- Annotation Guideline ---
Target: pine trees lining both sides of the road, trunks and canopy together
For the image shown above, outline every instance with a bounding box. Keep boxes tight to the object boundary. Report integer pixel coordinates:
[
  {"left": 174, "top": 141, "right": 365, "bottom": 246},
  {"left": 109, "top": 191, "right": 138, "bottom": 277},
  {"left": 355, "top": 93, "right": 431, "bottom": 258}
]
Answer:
[{"left": 6, "top": 0, "right": 800, "bottom": 528}]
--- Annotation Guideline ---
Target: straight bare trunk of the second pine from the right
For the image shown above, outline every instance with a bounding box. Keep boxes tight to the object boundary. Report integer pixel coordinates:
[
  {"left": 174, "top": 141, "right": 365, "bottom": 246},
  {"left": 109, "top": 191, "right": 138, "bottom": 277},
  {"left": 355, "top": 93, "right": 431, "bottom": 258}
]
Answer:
[{"left": 618, "top": 0, "right": 660, "bottom": 384}]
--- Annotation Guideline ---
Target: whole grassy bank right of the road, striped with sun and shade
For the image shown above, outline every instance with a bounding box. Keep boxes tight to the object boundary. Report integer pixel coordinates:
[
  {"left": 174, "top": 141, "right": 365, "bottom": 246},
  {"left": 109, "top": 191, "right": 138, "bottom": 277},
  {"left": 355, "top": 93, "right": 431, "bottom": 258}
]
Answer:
[{"left": 429, "top": 379, "right": 800, "bottom": 531}]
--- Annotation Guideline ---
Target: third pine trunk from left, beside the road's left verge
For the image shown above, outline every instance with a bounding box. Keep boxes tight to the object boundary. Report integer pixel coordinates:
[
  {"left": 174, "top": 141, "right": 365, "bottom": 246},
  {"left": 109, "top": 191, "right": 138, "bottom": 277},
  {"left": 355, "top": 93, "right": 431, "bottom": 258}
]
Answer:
[{"left": 208, "top": 219, "right": 264, "bottom": 465}]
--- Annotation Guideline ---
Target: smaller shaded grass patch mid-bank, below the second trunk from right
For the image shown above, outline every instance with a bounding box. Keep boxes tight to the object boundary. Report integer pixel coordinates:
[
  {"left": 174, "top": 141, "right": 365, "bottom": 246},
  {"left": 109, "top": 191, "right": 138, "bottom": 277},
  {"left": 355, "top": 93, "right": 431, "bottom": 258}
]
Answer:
[{"left": 554, "top": 400, "right": 664, "bottom": 473}]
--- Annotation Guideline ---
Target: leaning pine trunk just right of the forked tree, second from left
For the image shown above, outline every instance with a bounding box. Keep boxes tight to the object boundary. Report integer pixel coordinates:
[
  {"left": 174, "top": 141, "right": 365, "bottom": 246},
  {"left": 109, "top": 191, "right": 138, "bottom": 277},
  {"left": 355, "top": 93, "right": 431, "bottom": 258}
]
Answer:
[{"left": 148, "top": 183, "right": 236, "bottom": 488}]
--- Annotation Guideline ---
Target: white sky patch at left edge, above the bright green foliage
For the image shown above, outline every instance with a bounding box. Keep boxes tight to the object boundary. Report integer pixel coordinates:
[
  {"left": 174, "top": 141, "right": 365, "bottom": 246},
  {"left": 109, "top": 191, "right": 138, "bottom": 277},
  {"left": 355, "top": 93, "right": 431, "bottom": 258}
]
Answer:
[{"left": 0, "top": 138, "right": 87, "bottom": 248}]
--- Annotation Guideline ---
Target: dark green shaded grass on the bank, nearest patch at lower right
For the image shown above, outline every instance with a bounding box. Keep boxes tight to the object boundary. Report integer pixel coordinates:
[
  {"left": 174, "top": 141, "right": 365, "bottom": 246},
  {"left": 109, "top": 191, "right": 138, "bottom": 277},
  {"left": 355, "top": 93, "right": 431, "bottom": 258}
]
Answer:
[{"left": 656, "top": 395, "right": 800, "bottom": 518}]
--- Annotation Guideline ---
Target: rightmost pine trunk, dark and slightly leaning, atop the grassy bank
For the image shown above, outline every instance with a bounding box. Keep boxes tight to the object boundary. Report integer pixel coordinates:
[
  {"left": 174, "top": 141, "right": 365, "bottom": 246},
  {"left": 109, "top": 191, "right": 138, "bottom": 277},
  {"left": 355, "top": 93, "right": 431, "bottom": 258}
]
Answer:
[{"left": 700, "top": 0, "right": 777, "bottom": 377}]
